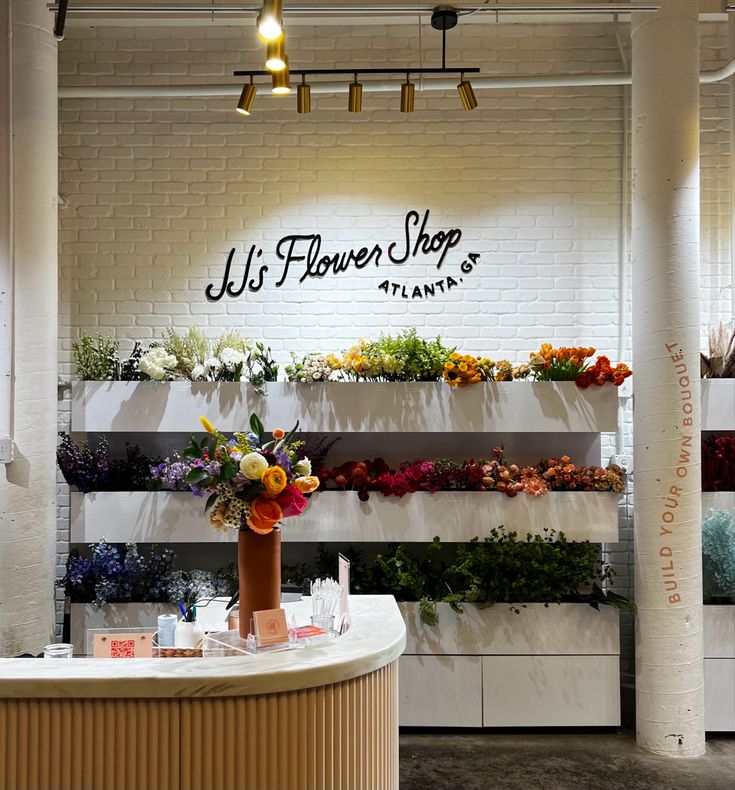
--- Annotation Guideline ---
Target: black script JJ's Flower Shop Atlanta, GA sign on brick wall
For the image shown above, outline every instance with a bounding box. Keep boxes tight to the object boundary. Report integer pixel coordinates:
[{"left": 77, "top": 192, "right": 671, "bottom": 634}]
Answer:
[{"left": 204, "top": 209, "right": 480, "bottom": 302}]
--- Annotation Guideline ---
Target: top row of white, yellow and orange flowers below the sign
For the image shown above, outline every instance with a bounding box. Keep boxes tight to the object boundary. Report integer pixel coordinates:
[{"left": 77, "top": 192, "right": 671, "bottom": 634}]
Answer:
[{"left": 74, "top": 327, "right": 632, "bottom": 394}]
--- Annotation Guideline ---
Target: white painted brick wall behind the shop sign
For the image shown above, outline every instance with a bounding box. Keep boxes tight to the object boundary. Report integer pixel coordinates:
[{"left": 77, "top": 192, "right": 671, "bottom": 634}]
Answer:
[{"left": 54, "top": 24, "right": 731, "bottom": 688}]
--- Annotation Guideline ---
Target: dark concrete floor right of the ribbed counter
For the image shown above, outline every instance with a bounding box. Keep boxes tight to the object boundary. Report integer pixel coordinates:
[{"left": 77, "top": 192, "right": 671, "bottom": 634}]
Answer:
[{"left": 400, "top": 731, "right": 735, "bottom": 790}]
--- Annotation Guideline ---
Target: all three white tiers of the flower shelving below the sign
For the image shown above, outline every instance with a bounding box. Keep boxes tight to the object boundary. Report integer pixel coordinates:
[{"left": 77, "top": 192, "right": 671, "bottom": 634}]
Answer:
[{"left": 71, "top": 382, "right": 620, "bottom": 727}]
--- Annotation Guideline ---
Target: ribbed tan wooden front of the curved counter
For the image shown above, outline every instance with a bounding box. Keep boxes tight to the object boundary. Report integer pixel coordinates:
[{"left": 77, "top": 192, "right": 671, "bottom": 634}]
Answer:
[{"left": 0, "top": 597, "right": 405, "bottom": 790}]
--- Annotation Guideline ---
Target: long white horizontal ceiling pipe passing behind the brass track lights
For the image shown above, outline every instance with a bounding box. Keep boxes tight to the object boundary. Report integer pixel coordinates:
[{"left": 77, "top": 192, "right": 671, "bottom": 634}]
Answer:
[{"left": 59, "top": 58, "right": 735, "bottom": 99}]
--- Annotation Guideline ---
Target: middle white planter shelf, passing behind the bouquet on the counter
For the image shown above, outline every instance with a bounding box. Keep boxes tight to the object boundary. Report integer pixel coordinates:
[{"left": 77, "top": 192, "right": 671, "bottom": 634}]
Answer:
[{"left": 71, "top": 491, "right": 619, "bottom": 543}]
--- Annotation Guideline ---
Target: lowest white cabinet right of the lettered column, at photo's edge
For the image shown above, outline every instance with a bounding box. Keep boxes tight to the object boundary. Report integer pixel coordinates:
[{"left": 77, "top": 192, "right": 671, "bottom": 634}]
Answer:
[{"left": 704, "top": 605, "right": 735, "bottom": 732}]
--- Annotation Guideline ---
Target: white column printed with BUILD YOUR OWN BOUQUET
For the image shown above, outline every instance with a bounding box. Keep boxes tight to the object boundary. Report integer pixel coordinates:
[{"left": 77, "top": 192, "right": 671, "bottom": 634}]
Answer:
[{"left": 632, "top": 0, "right": 705, "bottom": 757}]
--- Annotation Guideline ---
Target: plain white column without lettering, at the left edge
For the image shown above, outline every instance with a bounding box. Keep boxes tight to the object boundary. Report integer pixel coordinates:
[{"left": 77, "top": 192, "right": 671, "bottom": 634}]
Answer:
[{"left": 0, "top": 0, "right": 58, "bottom": 655}]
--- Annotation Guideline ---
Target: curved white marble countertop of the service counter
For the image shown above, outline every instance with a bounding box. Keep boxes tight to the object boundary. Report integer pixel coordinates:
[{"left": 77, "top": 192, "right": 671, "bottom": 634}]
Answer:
[{"left": 0, "top": 595, "right": 406, "bottom": 699}]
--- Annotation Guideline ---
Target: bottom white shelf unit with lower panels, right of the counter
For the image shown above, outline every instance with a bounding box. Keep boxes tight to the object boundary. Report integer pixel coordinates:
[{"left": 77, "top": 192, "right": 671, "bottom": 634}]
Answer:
[{"left": 399, "top": 604, "right": 620, "bottom": 727}]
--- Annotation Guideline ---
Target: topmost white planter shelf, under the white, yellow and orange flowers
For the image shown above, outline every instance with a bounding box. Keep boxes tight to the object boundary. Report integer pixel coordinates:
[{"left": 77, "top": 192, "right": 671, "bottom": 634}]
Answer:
[{"left": 71, "top": 381, "right": 618, "bottom": 433}]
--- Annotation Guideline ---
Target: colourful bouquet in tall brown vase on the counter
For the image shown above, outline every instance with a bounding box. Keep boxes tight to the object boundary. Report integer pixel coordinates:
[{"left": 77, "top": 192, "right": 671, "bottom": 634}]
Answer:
[{"left": 183, "top": 414, "right": 319, "bottom": 639}]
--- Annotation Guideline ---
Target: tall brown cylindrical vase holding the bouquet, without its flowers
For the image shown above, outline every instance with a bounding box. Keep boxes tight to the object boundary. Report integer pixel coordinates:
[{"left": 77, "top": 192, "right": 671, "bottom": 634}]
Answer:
[{"left": 237, "top": 528, "right": 281, "bottom": 639}]
